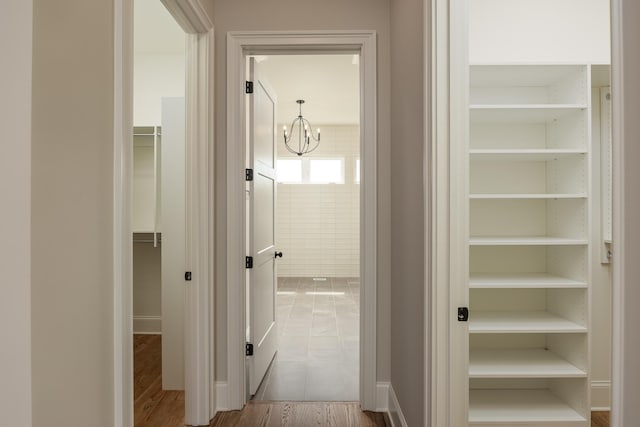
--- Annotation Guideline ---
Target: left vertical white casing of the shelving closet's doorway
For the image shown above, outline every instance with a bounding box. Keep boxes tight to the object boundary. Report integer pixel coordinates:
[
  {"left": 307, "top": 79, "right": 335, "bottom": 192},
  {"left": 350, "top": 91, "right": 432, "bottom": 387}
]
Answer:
[{"left": 425, "top": 0, "right": 469, "bottom": 426}]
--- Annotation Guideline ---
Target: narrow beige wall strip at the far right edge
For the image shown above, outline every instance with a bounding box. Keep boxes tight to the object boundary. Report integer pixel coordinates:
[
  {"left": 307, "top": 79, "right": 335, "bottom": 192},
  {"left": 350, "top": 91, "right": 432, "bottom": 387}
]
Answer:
[{"left": 612, "top": 0, "right": 640, "bottom": 426}]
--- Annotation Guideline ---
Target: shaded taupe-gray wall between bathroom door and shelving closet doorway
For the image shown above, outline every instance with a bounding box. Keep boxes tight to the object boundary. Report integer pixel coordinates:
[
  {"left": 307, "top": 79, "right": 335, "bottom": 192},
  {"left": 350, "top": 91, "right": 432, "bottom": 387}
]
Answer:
[{"left": 391, "top": 0, "right": 426, "bottom": 426}]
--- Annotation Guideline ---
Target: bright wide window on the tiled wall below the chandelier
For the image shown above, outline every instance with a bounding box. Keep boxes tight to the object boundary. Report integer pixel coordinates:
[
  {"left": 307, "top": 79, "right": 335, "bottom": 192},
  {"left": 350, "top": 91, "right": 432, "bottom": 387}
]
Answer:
[{"left": 277, "top": 157, "right": 344, "bottom": 184}]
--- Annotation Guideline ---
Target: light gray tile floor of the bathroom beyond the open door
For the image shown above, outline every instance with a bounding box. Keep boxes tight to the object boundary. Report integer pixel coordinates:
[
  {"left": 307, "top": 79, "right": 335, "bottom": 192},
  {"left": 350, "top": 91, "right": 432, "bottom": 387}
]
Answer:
[{"left": 254, "top": 277, "right": 360, "bottom": 401}]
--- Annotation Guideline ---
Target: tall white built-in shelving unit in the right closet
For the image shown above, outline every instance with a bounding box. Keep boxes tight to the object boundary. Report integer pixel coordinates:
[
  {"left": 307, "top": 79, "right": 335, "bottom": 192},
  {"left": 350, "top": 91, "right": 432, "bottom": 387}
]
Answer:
[{"left": 468, "top": 65, "right": 591, "bottom": 427}]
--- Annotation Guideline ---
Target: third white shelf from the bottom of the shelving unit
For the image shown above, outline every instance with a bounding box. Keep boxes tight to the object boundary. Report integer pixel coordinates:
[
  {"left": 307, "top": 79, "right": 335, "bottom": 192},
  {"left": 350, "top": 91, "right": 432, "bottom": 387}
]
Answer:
[{"left": 469, "top": 310, "right": 587, "bottom": 334}]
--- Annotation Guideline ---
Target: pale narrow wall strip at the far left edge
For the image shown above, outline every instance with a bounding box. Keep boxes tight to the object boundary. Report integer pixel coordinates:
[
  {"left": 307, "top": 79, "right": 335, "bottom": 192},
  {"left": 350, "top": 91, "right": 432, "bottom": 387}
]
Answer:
[{"left": 0, "top": 0, "right": 33, "bottom": 427}]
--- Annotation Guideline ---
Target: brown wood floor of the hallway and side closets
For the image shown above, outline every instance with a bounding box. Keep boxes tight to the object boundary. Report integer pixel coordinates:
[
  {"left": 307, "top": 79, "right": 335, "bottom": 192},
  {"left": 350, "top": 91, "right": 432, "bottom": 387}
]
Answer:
[{"left": 133, "top": 335, "right": 609, "bottom": 427}]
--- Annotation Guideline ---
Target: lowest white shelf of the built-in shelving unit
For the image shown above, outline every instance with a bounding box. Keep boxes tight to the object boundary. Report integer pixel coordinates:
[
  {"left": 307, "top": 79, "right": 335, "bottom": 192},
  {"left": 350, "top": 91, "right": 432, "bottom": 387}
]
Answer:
[{"left": 469, "top": 390, "right": 587, "bottom": 427}]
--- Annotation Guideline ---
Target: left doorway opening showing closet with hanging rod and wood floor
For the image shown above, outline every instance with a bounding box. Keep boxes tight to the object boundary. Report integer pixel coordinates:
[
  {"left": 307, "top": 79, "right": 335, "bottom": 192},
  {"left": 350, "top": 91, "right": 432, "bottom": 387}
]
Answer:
[{"left": 132, "top": 0, "right": 186, "bottom": 425}]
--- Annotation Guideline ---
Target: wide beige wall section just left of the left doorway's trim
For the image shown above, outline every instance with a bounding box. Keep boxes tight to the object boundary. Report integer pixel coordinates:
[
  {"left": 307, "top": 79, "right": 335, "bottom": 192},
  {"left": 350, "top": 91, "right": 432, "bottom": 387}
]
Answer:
[{"left": 31, "top": 0, "right": 114, "bottom": 427}]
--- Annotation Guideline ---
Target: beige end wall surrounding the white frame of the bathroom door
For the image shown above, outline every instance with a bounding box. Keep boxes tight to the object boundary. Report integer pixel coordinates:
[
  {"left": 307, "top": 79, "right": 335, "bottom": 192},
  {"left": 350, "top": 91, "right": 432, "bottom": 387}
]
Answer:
[{"left": 211, "top": 0, "right": 390, "bottom": 381}]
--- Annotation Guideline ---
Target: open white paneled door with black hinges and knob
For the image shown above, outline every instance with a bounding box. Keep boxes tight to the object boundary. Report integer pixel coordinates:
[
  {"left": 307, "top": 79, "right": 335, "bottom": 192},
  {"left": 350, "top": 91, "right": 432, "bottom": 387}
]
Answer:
[{"left": 247, "top": 58, "right": 278, "bottom": 395}]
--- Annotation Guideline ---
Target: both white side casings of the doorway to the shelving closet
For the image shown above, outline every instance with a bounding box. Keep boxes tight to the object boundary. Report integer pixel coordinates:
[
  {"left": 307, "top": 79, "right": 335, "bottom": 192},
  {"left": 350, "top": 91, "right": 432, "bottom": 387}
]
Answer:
[{"left": 424, "top": 0, "right": 636, "bottom": 427}]
